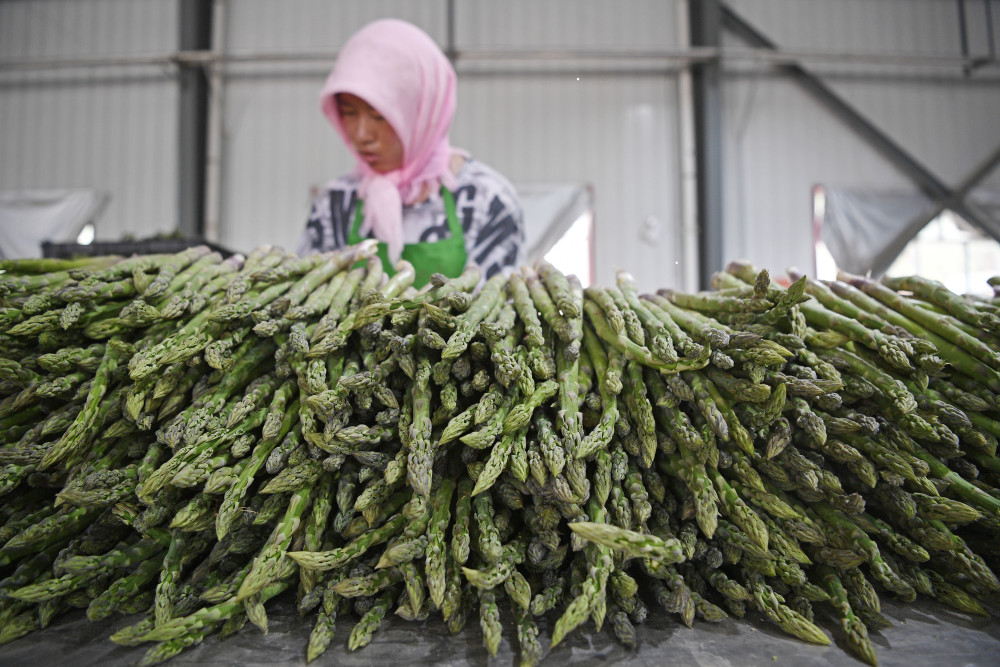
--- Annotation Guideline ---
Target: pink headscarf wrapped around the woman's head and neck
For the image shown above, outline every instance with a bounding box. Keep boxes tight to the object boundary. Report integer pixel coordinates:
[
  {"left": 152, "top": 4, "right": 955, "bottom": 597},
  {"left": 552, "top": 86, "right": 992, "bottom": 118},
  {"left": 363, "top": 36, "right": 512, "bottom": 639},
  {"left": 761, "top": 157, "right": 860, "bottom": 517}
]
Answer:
[{"left": 320, "top": 19, "right": 455, "bottom": 262}]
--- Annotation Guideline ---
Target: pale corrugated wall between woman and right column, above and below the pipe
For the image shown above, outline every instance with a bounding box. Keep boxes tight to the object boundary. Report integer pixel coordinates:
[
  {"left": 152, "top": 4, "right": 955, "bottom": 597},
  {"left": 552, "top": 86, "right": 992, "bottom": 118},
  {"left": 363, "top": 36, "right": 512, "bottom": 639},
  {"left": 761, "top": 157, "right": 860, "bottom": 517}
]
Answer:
[{"left": 454, "top": 0, "right": 684, "bottom": 288}]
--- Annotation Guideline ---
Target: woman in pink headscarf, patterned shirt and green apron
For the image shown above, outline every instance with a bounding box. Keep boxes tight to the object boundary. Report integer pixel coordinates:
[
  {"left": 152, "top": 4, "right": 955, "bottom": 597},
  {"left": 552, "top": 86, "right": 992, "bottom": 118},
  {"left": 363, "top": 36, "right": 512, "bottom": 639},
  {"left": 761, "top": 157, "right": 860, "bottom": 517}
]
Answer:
[{"left": 299, "top": 19, "right": 524, "bottom": 286}]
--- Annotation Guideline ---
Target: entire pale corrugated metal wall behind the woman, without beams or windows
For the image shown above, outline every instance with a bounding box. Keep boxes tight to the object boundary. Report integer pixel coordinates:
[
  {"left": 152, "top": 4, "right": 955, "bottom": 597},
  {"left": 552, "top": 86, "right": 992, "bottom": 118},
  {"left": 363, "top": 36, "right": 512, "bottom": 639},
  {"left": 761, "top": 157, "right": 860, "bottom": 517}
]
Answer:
[{"left": 0, "top": 0, "right": 1000, "bottom": 288}]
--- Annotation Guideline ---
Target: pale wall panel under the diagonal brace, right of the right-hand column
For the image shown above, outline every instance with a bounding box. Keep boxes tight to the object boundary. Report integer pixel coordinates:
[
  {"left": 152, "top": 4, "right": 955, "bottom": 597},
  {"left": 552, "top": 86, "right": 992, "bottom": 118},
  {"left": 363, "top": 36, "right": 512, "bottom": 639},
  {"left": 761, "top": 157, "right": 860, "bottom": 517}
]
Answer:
[{"left": 717, "top": 75, "right": 908, "bottom": 274}]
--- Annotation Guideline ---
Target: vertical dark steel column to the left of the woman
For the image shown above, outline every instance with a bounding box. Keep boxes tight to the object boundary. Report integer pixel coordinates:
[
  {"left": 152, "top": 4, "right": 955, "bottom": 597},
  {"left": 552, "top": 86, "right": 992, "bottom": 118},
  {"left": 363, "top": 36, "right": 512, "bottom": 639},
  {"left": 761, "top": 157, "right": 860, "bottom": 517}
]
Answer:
[{"left": 177, "top": 0, "right": 212, "bottom": 238}]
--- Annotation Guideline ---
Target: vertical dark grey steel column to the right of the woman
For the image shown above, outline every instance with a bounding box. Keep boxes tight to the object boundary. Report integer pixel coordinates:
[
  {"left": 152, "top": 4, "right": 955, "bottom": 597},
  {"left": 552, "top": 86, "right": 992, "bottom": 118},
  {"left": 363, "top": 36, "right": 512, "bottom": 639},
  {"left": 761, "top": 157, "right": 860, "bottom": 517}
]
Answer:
[{"left": 688, "top": 0, "right": 725, "bottom": 289}]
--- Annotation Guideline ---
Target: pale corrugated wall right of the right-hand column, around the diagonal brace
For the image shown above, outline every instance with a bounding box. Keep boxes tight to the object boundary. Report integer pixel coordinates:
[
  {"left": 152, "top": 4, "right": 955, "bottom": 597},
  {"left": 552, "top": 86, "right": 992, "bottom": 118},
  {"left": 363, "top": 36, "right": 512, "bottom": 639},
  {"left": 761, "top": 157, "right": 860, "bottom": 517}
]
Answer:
[{"left": 722, "top": 0, "right": 1000, "bottom": 278}]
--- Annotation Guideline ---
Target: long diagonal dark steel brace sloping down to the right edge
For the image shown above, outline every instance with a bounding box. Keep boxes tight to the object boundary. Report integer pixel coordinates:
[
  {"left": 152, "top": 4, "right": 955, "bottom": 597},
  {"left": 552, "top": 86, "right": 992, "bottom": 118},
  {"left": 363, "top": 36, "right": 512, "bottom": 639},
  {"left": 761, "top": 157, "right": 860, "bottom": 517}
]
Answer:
[{"left": 720, "top": 3, "right": 996, "bottom": 240}]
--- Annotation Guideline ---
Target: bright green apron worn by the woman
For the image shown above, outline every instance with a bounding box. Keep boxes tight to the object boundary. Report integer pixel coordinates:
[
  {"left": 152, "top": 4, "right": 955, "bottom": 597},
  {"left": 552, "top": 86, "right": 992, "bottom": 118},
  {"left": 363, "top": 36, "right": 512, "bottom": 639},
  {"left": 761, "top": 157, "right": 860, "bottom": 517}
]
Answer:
[{"left": 347, "top": 186, "right": 467, "bottom": 288}]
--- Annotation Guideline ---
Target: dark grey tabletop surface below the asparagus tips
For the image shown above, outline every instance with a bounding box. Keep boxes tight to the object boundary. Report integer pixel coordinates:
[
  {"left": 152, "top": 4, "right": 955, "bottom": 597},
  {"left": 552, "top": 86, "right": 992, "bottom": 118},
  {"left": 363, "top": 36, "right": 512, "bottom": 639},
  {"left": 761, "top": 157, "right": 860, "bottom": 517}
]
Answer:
[{"left": 0, "top": 599, "right": 1000, "bottom": 667}]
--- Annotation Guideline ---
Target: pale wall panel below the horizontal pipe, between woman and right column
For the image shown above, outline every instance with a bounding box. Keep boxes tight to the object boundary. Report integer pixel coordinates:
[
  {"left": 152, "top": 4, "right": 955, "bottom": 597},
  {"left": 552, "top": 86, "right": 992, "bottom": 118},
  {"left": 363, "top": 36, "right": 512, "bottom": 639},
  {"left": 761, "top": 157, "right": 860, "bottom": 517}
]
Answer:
[{"left": 452, "top": 75, "right": 684, "bottom": 289}]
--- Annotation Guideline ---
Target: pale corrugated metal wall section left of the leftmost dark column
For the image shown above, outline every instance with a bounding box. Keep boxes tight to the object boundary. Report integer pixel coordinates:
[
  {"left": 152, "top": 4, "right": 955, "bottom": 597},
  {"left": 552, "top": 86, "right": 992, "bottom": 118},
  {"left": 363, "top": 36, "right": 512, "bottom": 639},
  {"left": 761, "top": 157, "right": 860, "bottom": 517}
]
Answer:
[{"left": 0, "top": 0, "right": 178, "bottom": 240}]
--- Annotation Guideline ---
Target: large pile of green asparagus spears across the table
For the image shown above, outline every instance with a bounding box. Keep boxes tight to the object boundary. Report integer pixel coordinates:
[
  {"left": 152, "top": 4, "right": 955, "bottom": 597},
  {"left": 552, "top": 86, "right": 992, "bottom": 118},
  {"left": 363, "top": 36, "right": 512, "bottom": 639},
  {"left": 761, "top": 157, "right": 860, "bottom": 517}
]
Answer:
[{"left": 0, "top": 243, "right": 1000, "bottom": 665}]
